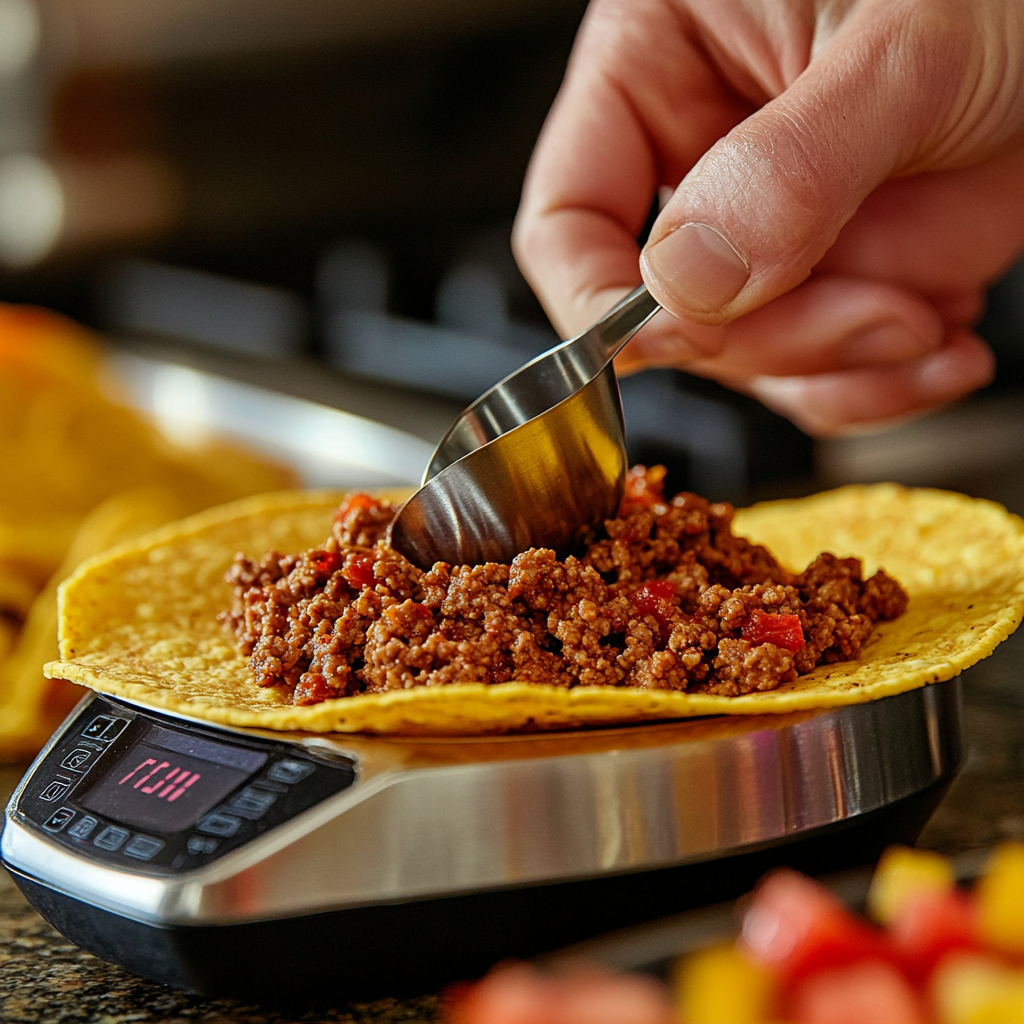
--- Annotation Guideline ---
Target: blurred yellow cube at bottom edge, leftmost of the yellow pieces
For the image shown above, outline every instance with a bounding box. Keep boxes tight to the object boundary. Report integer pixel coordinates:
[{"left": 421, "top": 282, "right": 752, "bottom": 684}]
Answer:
[{"left": 673, "top": 945, "right": 774, "bottom": 1024}]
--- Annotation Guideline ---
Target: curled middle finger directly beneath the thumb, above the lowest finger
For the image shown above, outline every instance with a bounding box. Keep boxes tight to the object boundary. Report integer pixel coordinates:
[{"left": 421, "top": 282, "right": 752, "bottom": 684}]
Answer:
[{"left": 615, "top": 276, "right": 947, "bottom": 380}]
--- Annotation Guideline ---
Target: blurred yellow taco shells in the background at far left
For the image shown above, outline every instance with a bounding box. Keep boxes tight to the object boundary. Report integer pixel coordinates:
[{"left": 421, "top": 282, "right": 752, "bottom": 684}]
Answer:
[{"left": 0, "top": 304, "right": 295, "bottom": 760}]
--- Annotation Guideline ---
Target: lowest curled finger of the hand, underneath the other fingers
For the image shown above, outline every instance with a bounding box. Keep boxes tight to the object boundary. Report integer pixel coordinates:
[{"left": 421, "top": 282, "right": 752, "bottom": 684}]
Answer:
[{"left": 741, "top": 330, "right": 995, "bottom": 437}]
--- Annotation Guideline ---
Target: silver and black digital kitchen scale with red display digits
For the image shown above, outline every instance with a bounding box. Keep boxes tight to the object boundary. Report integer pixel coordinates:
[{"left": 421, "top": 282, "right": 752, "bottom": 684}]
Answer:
[{"left": 2, "top": 679, "right": 962, "bottom": 999}]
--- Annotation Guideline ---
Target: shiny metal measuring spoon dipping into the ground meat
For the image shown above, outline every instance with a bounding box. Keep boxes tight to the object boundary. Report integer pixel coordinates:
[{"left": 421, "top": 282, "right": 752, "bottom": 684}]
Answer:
[{"left": 391, "top": 287, "right": 660, "bottom": 568}]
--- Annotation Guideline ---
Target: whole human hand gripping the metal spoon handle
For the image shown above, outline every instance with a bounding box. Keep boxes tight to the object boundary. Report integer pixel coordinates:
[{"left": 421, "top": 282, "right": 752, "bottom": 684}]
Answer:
[{"left": 513, "top": 0, "right": 1024, "bottom": 434}]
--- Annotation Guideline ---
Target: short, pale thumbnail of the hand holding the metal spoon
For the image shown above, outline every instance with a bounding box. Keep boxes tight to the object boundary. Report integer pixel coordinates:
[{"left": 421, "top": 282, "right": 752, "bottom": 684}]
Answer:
[{"left": 643, "top": 224, "right": 751, "bottom": 313}]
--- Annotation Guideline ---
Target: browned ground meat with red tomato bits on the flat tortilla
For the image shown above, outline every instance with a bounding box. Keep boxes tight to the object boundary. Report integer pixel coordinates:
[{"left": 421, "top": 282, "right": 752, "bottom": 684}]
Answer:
[{"left": 225, "top": 466, "right": 906, "bottom": 705}]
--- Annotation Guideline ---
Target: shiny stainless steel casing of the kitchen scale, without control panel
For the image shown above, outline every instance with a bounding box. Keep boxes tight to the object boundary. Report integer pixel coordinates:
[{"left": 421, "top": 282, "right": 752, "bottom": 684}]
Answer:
[{"left": 3, "top": 679, "right": 962, "bottom": 925}]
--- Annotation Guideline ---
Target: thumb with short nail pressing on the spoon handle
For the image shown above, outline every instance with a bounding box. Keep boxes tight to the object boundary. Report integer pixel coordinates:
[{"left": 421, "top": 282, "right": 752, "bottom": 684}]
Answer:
[{"left": 641, "top": 5, "right": 969, "bottom": 324}]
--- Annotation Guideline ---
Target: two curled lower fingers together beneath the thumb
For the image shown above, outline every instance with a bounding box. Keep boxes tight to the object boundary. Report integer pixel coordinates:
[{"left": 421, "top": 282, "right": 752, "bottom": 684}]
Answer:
[{"left": 616, "top": 276, "right": 994, "bottom": 436}]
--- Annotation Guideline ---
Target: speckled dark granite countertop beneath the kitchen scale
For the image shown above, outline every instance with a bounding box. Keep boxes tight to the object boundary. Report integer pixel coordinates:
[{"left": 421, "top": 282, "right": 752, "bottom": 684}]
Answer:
[{"left": 0, "top": 630, "right": 1024, "bottom": 1024}]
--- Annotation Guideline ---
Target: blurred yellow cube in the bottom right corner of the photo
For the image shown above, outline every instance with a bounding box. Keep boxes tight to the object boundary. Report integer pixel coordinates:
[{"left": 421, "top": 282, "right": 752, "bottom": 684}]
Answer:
[{"left": 932, "top": 953, "right": 1024, "bottom": 1024}]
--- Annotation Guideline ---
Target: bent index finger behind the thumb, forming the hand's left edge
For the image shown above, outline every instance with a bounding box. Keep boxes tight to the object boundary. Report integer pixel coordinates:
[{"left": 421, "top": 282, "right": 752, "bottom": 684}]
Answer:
[{"left": 512, "top": 0, "right": 752, "bottom": 337}]
